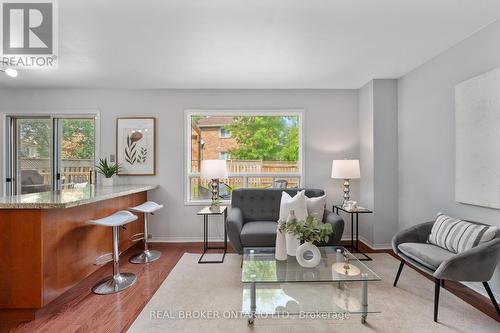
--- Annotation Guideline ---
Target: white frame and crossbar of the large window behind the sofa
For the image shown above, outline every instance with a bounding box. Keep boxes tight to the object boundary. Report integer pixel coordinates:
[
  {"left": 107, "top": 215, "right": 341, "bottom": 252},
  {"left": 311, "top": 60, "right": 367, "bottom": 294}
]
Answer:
[{"left": 184, "top": 109, "right": 306, "bottom": 206}]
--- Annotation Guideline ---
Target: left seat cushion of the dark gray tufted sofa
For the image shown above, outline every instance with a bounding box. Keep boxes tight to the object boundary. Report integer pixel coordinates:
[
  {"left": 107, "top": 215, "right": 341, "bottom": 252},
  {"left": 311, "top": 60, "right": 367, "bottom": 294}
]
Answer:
[{"left": 240, "top": 221, "right": 278, "bottom": 247}]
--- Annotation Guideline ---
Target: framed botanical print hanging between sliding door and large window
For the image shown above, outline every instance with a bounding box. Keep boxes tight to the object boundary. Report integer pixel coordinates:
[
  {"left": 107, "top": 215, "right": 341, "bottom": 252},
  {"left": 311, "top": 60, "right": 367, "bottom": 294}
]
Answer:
[{"left": 116, "top": 118, "right": 155, "bottom": 175}]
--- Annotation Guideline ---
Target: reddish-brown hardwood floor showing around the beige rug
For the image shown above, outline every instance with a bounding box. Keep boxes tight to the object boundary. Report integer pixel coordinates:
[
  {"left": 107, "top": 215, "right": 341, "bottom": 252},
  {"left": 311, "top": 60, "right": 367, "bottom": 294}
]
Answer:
[{"left": 0, "top": 243, "right": 500, "bottom": 333}]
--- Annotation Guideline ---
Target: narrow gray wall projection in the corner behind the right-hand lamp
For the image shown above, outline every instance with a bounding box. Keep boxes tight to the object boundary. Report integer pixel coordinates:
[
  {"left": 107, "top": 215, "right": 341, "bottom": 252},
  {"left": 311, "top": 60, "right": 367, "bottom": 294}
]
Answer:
[{"left": 359, "top": 79, "right": 398, "bottom": 248}]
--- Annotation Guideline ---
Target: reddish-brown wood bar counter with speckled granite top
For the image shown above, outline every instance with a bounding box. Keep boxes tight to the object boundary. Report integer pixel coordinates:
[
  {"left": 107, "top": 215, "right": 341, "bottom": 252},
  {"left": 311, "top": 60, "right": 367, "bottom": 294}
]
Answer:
[{"left": 0, "top": 185, "right": 157, "bottom": 322}]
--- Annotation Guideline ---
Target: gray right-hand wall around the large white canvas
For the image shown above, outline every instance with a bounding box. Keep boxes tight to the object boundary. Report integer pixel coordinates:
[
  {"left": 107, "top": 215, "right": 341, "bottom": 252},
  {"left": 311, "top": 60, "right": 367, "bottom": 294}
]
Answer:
[{"left": 398, "top": 22, "right": 500, "bottom": 294}]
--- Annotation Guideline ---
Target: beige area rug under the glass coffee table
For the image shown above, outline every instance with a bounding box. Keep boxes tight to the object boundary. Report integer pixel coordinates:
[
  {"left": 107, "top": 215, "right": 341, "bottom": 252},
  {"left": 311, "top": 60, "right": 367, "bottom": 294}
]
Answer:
[{"left": 128, "top": 254, "right": 500, "bottom": 333}]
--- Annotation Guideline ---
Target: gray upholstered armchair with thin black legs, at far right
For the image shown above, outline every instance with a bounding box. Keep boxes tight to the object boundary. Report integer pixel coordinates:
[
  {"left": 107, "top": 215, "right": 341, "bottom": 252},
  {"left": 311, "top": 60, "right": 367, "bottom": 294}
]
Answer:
[{"left": 392, "top": 221, "right": 500, "bottom": 322}]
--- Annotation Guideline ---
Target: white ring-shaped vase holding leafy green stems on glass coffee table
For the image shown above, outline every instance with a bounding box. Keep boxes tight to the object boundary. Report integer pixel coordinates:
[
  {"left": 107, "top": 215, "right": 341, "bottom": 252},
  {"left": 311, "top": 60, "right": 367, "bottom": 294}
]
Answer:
[{"left": 280, "top": 216, "right": 332, "bottom": 267}]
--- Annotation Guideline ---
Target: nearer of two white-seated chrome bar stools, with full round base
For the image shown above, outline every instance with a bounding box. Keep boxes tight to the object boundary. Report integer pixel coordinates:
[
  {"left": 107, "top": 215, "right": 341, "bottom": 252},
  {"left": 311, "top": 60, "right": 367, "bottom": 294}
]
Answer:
[{"left": 87, "top": 210, "right": 137, "bottom": 295}]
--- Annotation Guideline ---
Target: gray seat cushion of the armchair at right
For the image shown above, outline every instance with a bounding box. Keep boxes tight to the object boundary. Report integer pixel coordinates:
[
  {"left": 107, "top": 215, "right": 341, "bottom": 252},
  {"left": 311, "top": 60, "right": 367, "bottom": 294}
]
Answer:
[{"left": 398, "top": 243, "right": 455, "bottom": 271}]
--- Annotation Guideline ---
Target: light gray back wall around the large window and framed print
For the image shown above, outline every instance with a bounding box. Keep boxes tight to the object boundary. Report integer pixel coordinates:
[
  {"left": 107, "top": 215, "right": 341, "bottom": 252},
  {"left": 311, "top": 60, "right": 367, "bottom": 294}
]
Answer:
[{"left": 0, "top": 89, "right": 359, "bottom": 241}]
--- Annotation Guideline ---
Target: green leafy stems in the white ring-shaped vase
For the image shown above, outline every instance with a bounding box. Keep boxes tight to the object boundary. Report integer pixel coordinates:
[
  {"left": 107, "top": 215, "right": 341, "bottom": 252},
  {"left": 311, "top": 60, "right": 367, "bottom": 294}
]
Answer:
[{"left": 280, "top": 216, "right": 332, "bottom": 242}]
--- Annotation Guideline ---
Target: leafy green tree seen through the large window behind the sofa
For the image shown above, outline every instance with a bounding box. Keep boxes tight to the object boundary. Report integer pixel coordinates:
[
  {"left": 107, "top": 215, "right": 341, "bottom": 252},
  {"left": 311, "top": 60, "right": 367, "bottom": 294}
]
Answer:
[{"left": 226, "top": 116, "right": 299, "bottom": 161}]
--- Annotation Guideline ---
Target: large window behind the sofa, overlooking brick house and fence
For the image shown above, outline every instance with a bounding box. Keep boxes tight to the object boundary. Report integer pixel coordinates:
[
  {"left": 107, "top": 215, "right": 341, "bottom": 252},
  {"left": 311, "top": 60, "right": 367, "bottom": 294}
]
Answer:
[{"left": 185, "top": 110, "right": 304, "bottom": 204}]
